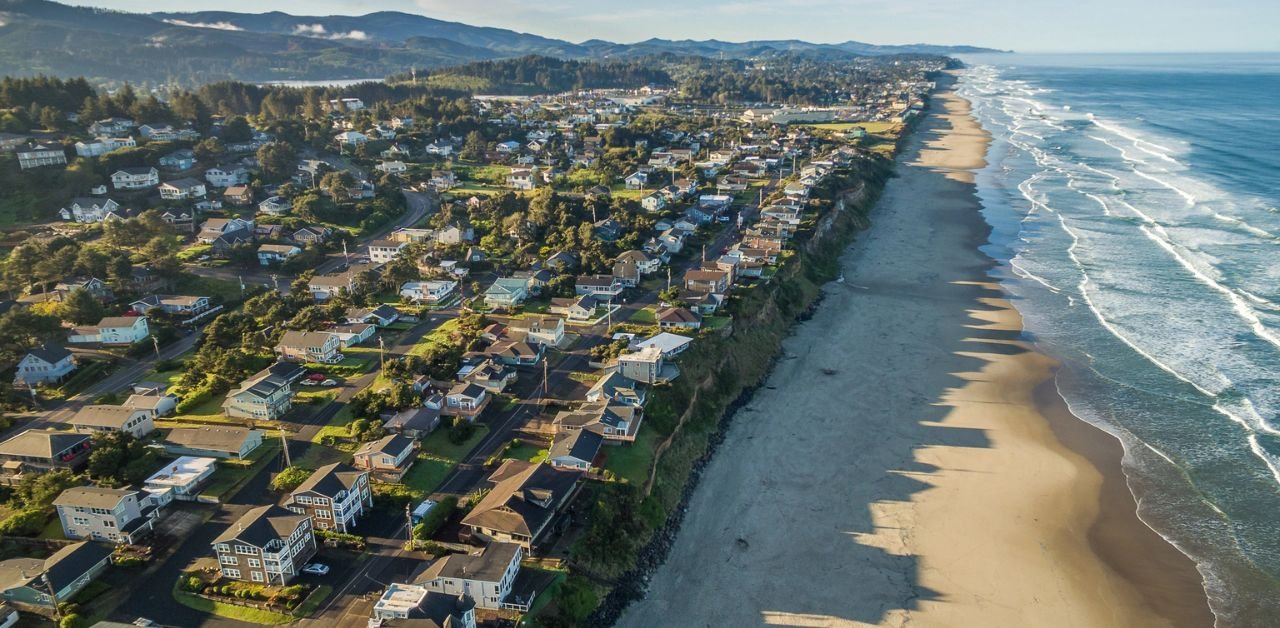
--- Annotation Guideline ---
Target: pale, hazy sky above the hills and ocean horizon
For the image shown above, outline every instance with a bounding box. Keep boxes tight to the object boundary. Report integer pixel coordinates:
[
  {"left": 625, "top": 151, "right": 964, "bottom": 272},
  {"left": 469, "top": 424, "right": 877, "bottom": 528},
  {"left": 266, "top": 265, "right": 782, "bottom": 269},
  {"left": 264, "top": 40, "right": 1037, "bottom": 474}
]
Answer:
[{"left": 74, "top": 0, "right": 1280, "bottom": 52}]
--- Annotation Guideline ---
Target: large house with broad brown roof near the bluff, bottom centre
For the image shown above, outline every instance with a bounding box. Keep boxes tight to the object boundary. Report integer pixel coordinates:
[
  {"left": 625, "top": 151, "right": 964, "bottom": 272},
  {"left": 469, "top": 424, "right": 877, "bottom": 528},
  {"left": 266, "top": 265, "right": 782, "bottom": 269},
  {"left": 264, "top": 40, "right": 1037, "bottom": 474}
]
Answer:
[{"left": 462, "top": 459, "right": 582, "bottom": 551}]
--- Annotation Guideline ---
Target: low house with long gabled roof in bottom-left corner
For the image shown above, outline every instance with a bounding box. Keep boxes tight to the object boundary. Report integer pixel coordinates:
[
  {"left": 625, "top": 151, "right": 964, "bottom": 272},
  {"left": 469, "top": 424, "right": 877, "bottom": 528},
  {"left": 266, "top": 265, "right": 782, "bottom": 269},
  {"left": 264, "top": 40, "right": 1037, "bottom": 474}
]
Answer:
[{"left": 0, "top": 541, "right": 111, "bottom": 613}]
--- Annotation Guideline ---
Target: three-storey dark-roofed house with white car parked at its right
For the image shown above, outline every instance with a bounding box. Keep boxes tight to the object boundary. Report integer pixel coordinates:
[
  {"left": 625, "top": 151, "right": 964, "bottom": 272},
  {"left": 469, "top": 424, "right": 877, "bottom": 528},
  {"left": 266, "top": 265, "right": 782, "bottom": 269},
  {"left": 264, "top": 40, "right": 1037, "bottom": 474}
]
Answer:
[{"left": 212, "top": 505, "right": 316, "bottom": 586}]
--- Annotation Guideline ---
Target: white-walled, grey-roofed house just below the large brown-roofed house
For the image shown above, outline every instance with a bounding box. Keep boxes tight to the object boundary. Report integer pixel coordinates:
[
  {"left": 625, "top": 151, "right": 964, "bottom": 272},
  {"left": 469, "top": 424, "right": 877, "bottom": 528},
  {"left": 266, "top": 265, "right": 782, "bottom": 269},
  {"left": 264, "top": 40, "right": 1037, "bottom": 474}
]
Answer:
[{"left": 413, "top": 542, "right": 527, "bottom": 609}]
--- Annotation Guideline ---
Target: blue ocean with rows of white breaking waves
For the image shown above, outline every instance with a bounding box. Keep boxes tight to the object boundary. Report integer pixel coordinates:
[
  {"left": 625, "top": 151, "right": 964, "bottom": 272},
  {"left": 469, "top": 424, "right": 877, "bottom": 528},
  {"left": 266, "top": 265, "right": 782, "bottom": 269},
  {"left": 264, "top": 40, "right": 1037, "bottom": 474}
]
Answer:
[{"left": 960, "top": 55, "right": 1280, "bottom": 625}]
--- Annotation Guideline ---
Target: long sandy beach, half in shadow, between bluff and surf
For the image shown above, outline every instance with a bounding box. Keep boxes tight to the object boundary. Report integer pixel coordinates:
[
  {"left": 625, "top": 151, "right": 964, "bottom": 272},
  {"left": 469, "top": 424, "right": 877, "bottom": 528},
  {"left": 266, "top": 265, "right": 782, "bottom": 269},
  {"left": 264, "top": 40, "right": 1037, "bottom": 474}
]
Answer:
[{"left": 620, "top": 76, "right": 1212, "bottom": 628}]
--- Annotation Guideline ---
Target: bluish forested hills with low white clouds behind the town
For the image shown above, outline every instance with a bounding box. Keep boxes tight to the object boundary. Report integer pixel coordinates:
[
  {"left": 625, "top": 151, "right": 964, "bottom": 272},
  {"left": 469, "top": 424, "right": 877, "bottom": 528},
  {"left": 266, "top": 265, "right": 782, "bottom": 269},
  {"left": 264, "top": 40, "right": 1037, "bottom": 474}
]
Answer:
[{"left": 0, "top": 0, "right": 1003, "bottom": 84}]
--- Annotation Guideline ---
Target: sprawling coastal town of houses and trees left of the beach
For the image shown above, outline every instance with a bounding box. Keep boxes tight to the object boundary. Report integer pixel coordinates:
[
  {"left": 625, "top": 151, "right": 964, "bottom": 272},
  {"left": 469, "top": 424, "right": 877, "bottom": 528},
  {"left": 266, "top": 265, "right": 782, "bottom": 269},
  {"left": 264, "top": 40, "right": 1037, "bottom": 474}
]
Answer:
[{"left": 0, "top": 55, "right": 948, "bottom": 628}]
